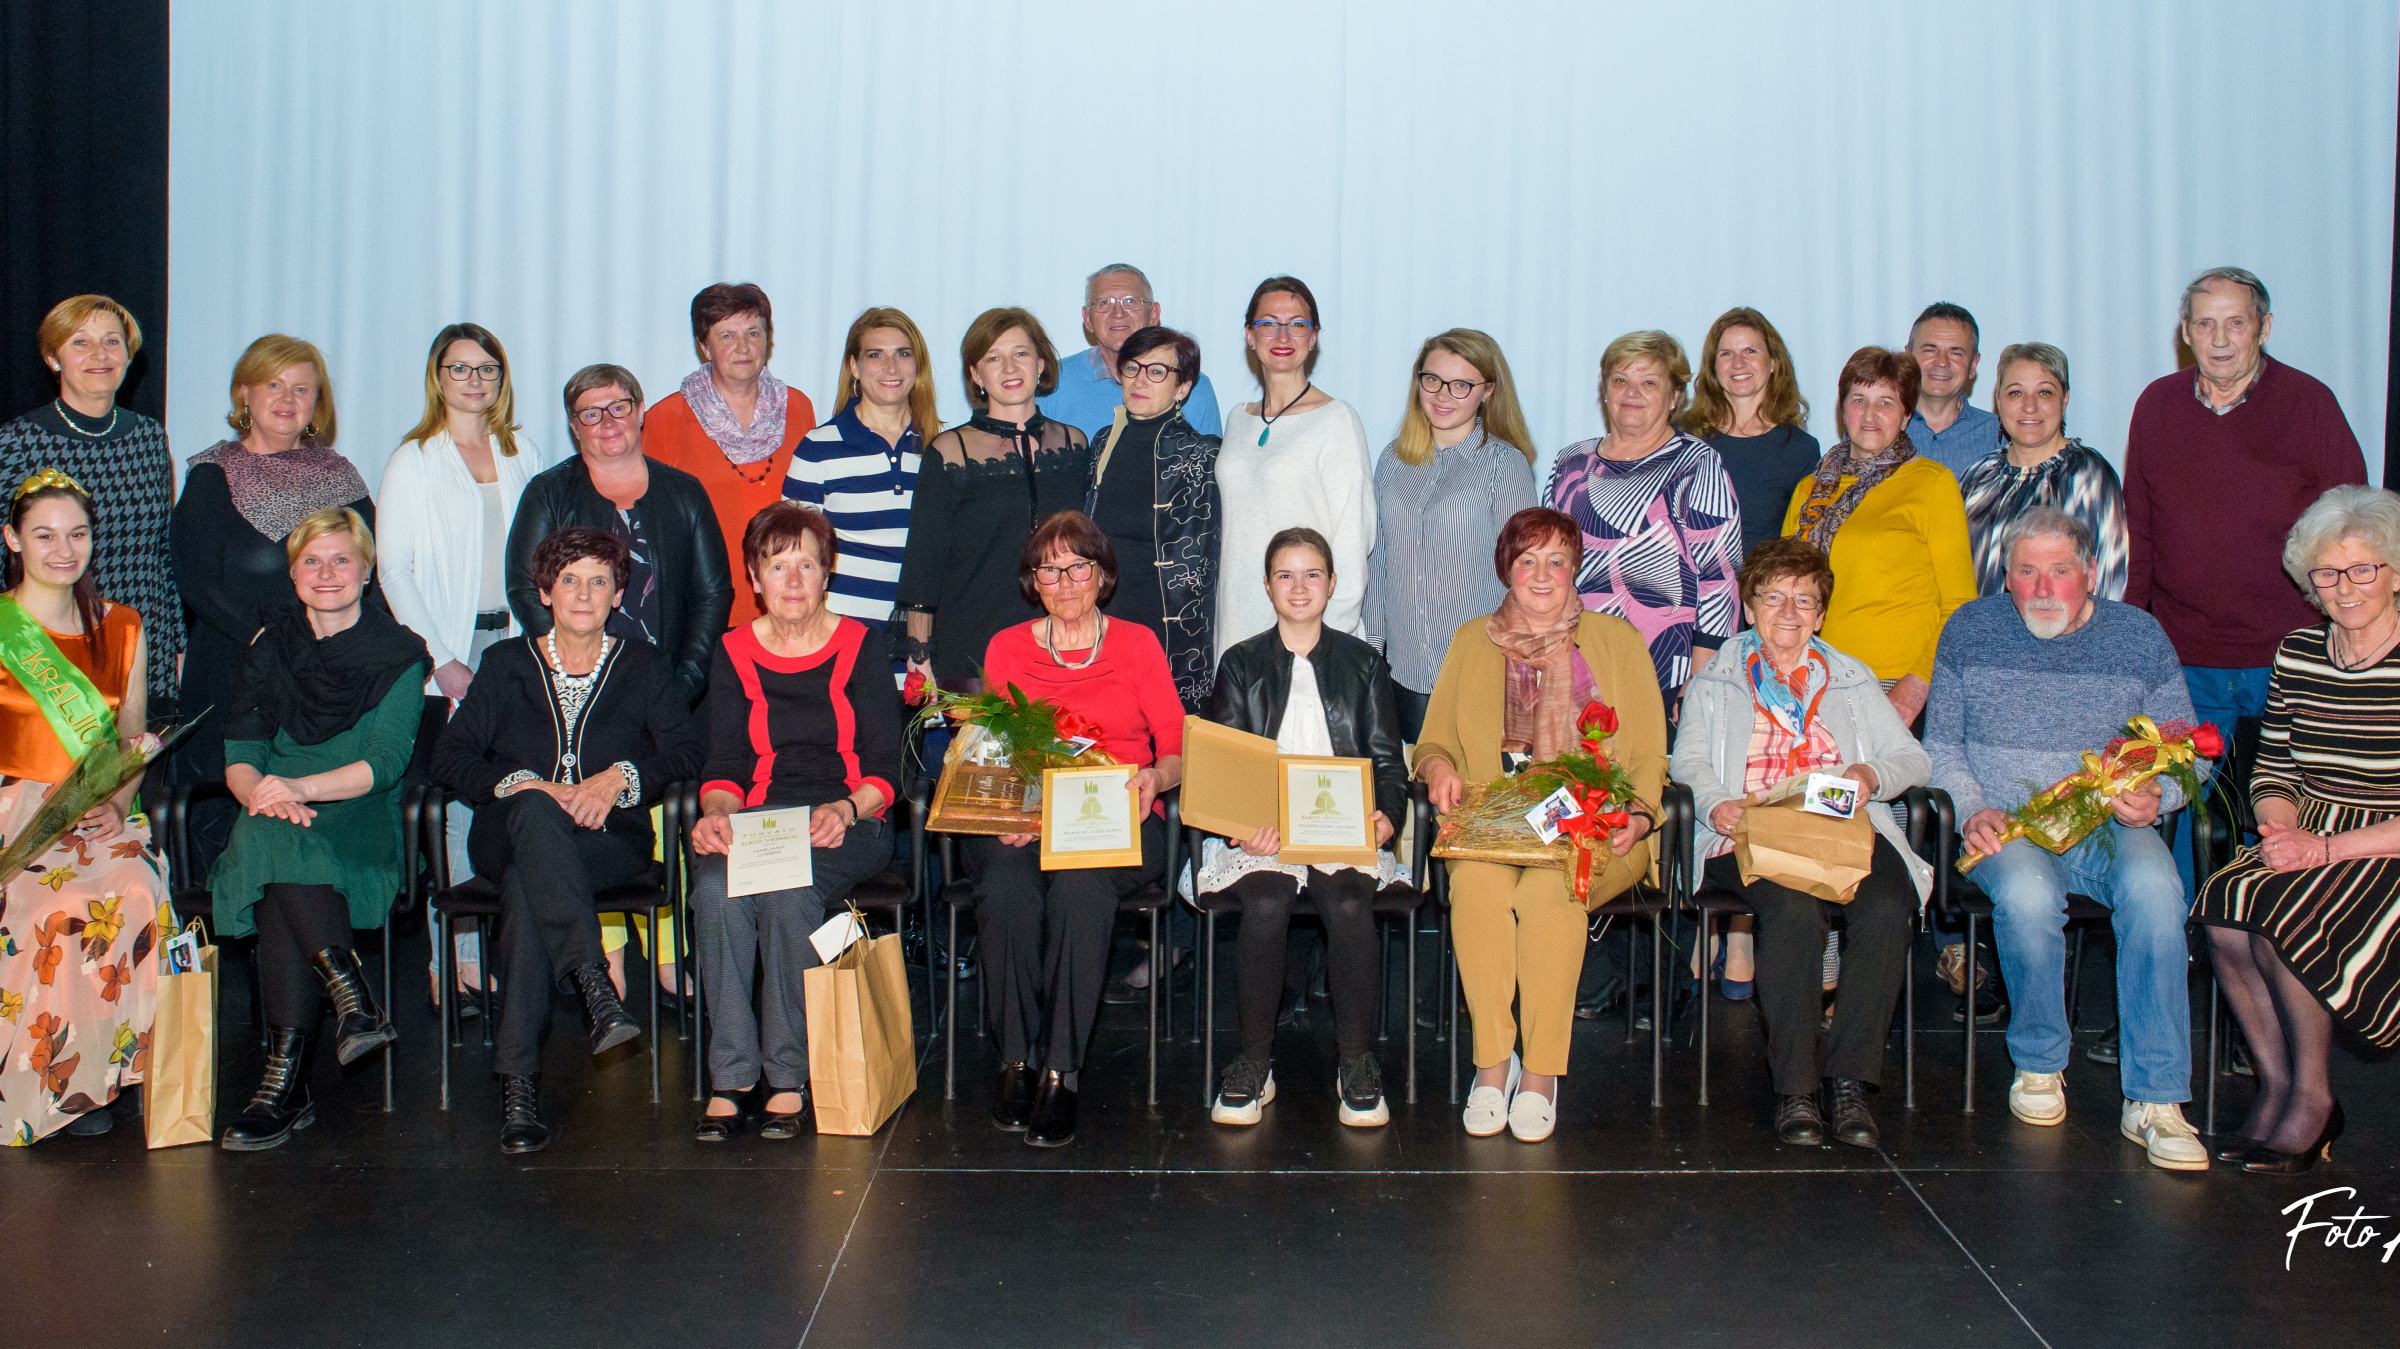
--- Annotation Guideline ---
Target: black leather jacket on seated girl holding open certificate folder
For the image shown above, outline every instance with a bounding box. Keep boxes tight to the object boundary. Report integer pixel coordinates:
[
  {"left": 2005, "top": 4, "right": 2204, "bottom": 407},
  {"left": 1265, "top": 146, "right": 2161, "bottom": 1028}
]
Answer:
[{"left": 1207, "top": 626, "right": 1409, "bottom": 826}]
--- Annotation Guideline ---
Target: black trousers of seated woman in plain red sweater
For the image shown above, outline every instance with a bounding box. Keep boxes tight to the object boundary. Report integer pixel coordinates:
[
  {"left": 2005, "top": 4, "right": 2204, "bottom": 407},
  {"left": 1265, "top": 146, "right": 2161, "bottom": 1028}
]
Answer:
[{"left": 967, "top": 816, "right": 1166, "bottom": 1073}]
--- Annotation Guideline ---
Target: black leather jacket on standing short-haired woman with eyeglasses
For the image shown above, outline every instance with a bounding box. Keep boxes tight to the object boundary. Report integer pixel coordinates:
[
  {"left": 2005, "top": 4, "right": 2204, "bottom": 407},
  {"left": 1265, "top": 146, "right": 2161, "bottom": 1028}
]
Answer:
[{"left": 509, "top": 454, "right": 734, "bottom": 708}]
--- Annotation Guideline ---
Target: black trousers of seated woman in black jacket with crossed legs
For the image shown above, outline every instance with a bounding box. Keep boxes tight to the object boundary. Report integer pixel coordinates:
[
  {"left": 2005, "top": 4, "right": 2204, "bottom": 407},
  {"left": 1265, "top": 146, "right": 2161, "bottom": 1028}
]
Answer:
[{"left": 466, "top": 792, "right": 650, "bottom": 1078}]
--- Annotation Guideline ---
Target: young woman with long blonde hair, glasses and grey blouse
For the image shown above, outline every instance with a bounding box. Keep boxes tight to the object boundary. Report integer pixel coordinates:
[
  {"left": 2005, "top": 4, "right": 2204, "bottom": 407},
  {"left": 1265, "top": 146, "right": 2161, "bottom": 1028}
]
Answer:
[{"left": 1366, "top": 329, "right": 1534, "bottom": 742}]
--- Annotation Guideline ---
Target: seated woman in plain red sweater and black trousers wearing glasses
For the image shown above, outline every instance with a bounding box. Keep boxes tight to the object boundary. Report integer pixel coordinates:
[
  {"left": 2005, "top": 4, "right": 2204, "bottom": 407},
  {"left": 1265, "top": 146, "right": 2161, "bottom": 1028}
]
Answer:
[{"left": 967, "top": 511, "right": 1183, "bottom": 1147}]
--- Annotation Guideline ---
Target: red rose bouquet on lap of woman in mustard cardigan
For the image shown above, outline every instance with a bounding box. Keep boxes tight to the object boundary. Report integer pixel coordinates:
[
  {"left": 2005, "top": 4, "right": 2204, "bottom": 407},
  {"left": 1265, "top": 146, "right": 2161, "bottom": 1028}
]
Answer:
[{"left": 1433, "top": 703, "right": 1634, "bottom": 903}]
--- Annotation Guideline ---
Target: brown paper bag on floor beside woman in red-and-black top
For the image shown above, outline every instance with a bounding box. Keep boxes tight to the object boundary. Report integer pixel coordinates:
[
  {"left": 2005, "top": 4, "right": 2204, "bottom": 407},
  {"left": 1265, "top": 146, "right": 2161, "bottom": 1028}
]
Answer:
[{"left": 802, "top": 921, "right": 917, "bottom": 1138}]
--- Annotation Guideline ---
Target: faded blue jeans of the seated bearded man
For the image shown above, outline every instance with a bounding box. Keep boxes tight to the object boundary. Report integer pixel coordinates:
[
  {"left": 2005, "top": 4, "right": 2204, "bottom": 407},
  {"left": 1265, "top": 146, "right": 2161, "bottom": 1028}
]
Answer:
[{"left": 1975, "top": 823, "right": 2191, "bottom": 1104}]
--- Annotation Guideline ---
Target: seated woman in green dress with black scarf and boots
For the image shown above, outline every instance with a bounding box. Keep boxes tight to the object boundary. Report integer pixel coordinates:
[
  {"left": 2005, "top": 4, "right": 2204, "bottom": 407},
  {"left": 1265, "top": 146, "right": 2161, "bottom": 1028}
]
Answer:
[{"left": 209, "top": 506, "right": 430, "bottom": 1152}]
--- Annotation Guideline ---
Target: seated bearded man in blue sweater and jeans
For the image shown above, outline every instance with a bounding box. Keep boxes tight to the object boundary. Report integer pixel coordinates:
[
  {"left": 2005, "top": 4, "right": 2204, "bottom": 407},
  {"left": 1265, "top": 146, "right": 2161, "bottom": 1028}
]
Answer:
[{"left": 1925, "top": 506, "right": 2208, "bottom": 1171}]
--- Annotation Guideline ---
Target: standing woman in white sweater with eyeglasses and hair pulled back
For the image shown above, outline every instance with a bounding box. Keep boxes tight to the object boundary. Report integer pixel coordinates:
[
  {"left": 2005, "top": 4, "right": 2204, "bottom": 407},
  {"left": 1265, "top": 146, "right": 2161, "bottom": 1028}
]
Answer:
[{"left": 1217, "top": 276, "right": 1375, "bottom": 658}]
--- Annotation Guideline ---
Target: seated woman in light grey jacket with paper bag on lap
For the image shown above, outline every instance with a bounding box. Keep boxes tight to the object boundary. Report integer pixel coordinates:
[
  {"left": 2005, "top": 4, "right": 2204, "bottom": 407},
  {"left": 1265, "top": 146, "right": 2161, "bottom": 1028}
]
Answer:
[{"left": 1673, "top": 538, "right": 1932, "bottom": 1147}]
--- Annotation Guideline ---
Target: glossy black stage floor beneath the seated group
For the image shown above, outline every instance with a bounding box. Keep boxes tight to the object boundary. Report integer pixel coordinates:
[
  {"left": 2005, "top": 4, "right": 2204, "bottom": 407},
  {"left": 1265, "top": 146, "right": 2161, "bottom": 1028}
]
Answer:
[{"left": 0, "top": 921, "right": 2400, "bottom": 1349}]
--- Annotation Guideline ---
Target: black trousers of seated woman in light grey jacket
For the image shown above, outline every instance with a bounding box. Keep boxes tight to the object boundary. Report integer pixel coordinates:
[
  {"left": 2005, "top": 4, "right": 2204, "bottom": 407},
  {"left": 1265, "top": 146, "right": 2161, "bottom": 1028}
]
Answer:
[{"left": 1709, "top": 835, "right": 1918, "bottom": 1097}]
